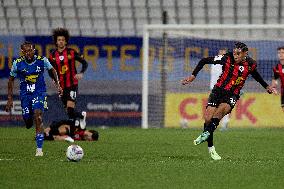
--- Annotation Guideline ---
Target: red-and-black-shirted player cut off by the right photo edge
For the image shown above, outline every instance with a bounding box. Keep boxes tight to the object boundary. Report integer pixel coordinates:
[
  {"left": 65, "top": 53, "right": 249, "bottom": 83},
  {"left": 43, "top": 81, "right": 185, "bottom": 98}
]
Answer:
[{"left": 272, "top": 46, "right": 284, "bottom": 112}]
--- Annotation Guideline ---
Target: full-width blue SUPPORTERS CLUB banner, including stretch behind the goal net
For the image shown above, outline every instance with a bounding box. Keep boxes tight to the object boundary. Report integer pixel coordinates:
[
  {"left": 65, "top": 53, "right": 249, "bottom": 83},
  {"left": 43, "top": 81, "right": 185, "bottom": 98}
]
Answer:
[{"left": 0, "top": 36, "right": 283, "bottom": 81}]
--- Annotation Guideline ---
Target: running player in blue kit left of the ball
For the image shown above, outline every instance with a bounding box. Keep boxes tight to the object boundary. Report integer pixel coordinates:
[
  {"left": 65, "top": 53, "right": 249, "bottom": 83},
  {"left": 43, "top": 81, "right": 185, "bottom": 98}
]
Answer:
[{"left": 6, "top": 42, "right": 62, "bottom": 156}]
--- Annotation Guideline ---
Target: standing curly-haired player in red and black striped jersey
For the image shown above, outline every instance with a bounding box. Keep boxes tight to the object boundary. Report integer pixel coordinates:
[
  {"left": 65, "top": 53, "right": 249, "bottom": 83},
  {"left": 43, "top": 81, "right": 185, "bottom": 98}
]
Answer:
[{"left": 49, "top": 28, "right": 88, "bottom": 129}]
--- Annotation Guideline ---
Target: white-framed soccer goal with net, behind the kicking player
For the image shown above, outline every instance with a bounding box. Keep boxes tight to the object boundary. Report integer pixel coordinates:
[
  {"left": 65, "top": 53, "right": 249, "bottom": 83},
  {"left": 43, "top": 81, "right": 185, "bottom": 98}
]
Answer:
[{"left": 142, "top": 25, "right": 284, "bottom": 128}]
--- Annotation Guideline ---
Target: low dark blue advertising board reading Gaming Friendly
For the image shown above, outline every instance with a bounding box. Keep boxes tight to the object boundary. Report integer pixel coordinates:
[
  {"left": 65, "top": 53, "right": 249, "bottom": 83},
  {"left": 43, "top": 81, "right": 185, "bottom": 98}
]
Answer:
[{"left": 0, "top": 95, "right": 142, "bottom": 127}]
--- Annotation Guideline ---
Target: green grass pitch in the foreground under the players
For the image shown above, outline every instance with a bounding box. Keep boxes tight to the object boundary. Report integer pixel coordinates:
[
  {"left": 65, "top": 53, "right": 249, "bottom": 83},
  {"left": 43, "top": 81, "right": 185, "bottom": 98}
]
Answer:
[{"left": 0, "top": 127, "right": 284, "bottom": 189}]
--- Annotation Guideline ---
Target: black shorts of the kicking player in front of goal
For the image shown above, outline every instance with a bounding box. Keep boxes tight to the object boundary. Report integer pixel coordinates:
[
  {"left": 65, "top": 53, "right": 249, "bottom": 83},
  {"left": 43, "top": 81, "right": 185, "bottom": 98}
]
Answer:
[{"left": 207, "top": 88, "right": 240, "bottom": 109}]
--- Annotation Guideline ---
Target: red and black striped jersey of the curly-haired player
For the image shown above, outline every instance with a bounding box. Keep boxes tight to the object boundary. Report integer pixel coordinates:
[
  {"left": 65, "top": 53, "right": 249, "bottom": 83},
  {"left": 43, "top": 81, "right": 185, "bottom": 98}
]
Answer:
[{"left": 49, "top": 48, "right": 88, "bottom": 89}]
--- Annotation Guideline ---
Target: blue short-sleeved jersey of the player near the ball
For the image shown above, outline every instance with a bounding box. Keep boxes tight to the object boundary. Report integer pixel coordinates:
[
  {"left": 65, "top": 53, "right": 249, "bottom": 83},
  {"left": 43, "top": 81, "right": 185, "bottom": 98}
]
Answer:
[{"left": 10, "top": 55, "right": 53, "bottom": 96}]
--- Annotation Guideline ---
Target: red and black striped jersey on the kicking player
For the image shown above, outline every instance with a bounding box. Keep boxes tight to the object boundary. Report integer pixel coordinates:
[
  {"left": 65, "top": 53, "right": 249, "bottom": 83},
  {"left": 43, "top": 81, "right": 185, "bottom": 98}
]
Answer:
[{"left": 192, "top": 53, "right": 268, "bottom": 95}]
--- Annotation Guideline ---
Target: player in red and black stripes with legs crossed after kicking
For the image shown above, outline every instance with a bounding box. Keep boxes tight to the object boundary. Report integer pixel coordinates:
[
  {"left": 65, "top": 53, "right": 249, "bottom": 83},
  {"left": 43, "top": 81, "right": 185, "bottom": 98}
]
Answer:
[{"left": 182, "top": 42, "right": 277, "bottom": 160}]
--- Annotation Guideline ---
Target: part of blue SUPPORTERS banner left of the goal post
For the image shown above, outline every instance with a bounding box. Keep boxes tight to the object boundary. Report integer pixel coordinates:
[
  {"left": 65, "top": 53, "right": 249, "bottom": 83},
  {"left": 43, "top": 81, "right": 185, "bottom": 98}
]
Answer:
[{"left": 0, "top": 36, "right": 142, "bottom": 80}]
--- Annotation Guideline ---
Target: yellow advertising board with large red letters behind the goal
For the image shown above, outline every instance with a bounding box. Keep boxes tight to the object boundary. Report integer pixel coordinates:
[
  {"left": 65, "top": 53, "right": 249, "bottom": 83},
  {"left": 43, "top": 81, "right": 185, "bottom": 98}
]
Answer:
[{"left": 165, "top": 93, "right": 284, "bottom": 128}]
